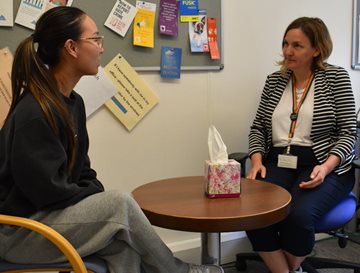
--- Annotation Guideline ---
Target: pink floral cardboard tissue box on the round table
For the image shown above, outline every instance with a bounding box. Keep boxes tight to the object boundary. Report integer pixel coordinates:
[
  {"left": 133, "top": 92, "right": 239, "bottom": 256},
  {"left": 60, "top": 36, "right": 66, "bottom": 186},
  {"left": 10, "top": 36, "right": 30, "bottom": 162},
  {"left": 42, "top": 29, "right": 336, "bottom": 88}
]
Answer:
[{"left": 205, "top": 159, "right": 240, "bottom": 198}]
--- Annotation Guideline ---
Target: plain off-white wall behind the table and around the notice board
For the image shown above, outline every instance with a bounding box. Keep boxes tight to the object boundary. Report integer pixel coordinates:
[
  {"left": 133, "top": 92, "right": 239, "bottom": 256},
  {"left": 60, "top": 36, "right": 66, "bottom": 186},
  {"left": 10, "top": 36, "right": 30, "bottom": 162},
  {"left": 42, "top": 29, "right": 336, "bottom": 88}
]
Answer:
[{"left": 88, "top": 0, "right": 360, "bottom": 260}]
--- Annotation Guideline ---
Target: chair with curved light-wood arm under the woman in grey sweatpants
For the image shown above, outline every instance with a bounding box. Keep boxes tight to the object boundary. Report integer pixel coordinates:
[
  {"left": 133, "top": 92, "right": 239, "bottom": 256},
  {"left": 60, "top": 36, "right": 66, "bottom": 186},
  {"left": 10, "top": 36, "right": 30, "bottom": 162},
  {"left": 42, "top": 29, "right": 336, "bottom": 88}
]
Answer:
[{"left": 0, "top": 214, "right": 108, "bottom": 273}]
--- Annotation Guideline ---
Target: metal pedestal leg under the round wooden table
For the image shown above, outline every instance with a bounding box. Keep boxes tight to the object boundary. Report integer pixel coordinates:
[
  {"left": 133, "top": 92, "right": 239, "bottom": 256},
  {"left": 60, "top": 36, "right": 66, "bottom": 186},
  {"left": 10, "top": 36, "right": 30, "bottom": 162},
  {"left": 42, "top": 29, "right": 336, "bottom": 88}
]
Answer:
[{"left": 201, "top": 233, "right": 221, "bottom": 265}]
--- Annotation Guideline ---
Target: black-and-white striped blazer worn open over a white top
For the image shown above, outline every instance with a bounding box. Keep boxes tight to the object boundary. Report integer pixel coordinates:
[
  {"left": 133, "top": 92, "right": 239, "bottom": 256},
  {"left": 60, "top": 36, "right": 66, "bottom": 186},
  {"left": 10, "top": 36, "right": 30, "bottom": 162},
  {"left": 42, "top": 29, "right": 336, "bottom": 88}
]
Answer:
[{"left": 249, "top": 64, "right": 356, "bottom": 174}]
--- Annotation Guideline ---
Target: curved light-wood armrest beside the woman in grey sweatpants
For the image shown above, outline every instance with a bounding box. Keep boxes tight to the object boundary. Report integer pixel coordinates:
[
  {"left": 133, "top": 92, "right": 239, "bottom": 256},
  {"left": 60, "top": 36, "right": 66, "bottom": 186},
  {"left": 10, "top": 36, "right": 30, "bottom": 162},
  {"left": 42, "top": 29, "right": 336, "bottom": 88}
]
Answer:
[{"left": 0, "top": 214, "right": 87, "bottom": 273}]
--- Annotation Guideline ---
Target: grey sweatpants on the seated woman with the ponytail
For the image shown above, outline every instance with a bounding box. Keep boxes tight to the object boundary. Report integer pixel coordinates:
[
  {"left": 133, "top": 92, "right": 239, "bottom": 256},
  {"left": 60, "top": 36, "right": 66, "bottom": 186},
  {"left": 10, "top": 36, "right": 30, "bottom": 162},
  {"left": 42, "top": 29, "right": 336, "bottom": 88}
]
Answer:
[{"left": 0, "top": 191, "right": 189, "bottom": 273}]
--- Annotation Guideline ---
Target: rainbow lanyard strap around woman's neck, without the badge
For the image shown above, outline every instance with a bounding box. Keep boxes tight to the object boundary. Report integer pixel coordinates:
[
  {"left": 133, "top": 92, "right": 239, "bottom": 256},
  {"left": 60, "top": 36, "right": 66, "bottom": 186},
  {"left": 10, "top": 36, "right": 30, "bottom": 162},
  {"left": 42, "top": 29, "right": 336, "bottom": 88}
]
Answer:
[{"left": 286, "top": 74, "right": 314, "bottom": 153}]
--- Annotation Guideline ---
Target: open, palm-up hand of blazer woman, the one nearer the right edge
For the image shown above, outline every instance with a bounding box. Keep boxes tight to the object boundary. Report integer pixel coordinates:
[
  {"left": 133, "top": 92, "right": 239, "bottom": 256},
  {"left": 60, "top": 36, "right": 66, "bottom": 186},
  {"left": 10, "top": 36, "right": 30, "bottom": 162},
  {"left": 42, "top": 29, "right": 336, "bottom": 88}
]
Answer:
[{"left": 299, "top": 155, "right": 340, "bottom": 189}]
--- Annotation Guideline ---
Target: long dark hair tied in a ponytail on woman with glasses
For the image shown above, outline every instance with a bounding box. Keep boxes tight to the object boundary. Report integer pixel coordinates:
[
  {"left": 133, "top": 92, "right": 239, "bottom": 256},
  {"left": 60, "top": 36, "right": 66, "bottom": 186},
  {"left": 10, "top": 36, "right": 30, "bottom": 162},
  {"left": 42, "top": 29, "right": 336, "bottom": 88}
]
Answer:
[{"left": 7, "top": 7, "right": 85, "bottom": 173}]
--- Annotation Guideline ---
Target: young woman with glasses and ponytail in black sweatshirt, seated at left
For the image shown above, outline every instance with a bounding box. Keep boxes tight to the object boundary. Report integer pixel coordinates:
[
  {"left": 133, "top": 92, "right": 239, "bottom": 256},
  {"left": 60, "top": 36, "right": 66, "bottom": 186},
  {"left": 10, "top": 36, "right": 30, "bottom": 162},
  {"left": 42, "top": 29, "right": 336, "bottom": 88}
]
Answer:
[{"left": 0, "top": 7, "right": 223, "bottom": 273}]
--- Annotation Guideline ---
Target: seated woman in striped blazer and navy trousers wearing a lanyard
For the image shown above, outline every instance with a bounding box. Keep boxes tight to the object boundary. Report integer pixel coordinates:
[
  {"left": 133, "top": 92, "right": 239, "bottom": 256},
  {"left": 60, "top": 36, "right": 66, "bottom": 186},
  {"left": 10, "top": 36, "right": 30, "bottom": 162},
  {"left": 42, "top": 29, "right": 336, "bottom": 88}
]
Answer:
[{"left": 247, "top": 17, "right": 356, "bottom": 273}]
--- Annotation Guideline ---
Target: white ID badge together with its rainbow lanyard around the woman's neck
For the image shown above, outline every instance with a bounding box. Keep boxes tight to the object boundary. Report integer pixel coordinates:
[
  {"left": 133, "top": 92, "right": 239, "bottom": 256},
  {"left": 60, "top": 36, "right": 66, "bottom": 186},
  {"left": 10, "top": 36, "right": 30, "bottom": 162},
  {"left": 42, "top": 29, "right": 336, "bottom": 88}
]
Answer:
[{"left": 277, "top": 75, "right": 314, "bottom": 169}]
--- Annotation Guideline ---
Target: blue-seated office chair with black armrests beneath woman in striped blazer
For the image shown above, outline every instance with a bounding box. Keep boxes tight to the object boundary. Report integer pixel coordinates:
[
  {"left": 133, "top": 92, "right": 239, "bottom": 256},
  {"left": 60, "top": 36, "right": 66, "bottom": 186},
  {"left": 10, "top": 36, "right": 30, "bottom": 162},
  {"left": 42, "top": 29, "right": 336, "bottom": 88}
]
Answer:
[{"left": 229, "top": 153, "right": 360, "bottom": 273}]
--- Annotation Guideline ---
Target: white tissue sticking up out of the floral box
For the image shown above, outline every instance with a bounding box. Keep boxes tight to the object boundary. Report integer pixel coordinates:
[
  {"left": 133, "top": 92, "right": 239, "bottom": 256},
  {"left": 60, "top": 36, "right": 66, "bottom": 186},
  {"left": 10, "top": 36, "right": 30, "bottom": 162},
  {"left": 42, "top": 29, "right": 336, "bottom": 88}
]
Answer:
[{"left": 208, "top": 125, "right": 228, "bottom": 164}]
